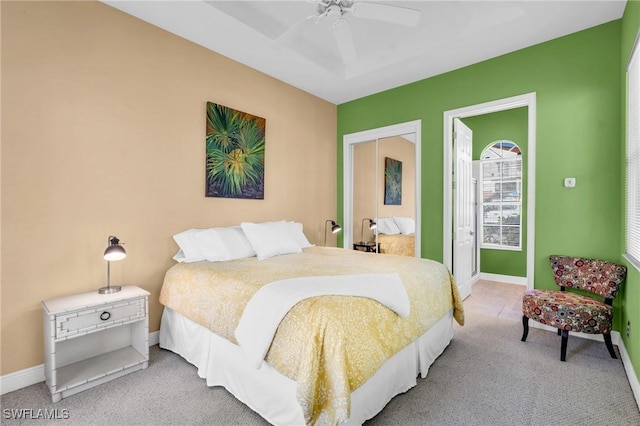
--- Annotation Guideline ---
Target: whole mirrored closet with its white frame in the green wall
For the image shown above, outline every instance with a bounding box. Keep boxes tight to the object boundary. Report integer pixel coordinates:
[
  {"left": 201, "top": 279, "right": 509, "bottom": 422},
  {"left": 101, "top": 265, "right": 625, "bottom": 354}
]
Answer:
[{"left": 343, "top": 120, "right": 422, "bottom": 257}]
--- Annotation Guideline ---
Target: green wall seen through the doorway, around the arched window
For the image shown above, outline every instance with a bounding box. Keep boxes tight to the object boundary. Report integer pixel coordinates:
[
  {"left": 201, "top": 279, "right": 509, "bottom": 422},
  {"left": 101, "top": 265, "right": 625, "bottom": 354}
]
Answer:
[{"left": 462, "top": 108, "right": 528, "bottom": 277}]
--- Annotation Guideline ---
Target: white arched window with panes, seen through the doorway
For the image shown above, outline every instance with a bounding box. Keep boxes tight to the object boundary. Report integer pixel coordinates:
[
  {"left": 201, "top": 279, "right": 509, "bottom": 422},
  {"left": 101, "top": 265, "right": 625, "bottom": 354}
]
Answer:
[{"left": 480, "top": 140, "right": 522, "bottom": 250}]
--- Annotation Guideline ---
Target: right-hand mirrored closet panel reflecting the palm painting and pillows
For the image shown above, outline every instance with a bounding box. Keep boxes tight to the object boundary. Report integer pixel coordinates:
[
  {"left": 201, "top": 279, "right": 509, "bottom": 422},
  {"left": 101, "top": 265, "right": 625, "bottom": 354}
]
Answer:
[{"left": 376, "top": 134, "right": 416, "bottom": 256}]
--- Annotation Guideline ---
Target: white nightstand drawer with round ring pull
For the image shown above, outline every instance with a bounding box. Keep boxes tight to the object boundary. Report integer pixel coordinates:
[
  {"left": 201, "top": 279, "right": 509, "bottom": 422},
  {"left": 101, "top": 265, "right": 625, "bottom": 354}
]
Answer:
[{"left": 55, "top": 298, "right": 147, "bottom": 340}]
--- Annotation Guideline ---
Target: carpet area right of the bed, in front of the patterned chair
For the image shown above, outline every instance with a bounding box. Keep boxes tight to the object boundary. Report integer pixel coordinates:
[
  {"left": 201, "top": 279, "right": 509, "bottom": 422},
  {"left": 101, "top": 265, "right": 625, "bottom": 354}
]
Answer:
[{"left": 367, "top": 317, "right": 640, "bottom": 426}]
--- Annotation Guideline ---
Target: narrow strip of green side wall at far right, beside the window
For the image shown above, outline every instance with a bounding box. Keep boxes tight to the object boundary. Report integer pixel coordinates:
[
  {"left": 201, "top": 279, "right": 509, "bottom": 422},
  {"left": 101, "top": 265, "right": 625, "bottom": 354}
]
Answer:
[{"left": 616, "top": 0, "right": 640, "bottom": 392}]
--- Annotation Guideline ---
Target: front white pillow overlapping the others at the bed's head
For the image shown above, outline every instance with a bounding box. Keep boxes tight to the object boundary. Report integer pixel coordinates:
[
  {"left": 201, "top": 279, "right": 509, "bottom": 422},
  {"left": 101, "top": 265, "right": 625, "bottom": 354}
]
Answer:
[{"left": 240, "top": 220, "right": 302, "bottom": 260}]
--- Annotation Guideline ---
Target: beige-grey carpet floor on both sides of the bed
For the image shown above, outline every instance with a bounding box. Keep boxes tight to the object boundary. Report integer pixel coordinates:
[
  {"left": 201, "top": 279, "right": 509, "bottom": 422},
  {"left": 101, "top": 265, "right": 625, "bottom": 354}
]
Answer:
[{"left": 0, "top": 282, "right": 640, "bottom": 426}]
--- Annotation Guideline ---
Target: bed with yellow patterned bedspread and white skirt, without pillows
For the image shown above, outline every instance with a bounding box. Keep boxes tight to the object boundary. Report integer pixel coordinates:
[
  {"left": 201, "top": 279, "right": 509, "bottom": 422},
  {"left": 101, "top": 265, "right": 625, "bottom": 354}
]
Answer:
[{"left": 160, "top": 221, "right": 464, "bottom": 425}]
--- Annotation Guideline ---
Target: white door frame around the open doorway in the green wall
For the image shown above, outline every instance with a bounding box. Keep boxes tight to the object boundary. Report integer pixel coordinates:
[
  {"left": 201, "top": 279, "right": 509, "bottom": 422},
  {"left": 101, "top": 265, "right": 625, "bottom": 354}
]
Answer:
[{"left": 443, "top": 93, "right": 536, "bottom": 298}]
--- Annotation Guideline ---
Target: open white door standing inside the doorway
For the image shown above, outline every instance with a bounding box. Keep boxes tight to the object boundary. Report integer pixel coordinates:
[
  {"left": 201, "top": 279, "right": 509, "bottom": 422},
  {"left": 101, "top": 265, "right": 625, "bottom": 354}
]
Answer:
[{"left": 453, "top": 118, "right": 475, "bottom": 298}]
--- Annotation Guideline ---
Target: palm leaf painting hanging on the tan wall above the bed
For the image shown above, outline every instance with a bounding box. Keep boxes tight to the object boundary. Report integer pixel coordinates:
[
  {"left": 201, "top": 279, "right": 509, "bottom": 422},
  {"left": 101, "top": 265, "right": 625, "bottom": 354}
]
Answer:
[{"left": 205, "top": 102, "right": 266, "bottom": 200}]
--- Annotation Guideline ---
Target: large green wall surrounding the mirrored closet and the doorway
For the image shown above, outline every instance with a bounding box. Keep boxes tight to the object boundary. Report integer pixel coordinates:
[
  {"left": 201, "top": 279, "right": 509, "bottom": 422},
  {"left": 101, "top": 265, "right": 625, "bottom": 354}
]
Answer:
[{"left": 337, "top": 15, "right": 640, "bottom": 382}]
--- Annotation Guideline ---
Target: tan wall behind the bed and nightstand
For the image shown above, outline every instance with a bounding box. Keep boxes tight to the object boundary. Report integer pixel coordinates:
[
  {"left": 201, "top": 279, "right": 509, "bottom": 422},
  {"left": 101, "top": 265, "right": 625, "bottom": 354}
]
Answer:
[{"left": 0, "top": 1, "right": 337, "bottom": 374}]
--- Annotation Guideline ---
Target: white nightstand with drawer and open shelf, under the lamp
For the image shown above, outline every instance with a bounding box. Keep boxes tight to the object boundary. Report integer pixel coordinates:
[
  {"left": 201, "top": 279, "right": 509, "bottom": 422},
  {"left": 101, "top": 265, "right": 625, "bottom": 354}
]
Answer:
[{"left": 42, "top": 286, "right": 149, "bottom": 402}]
